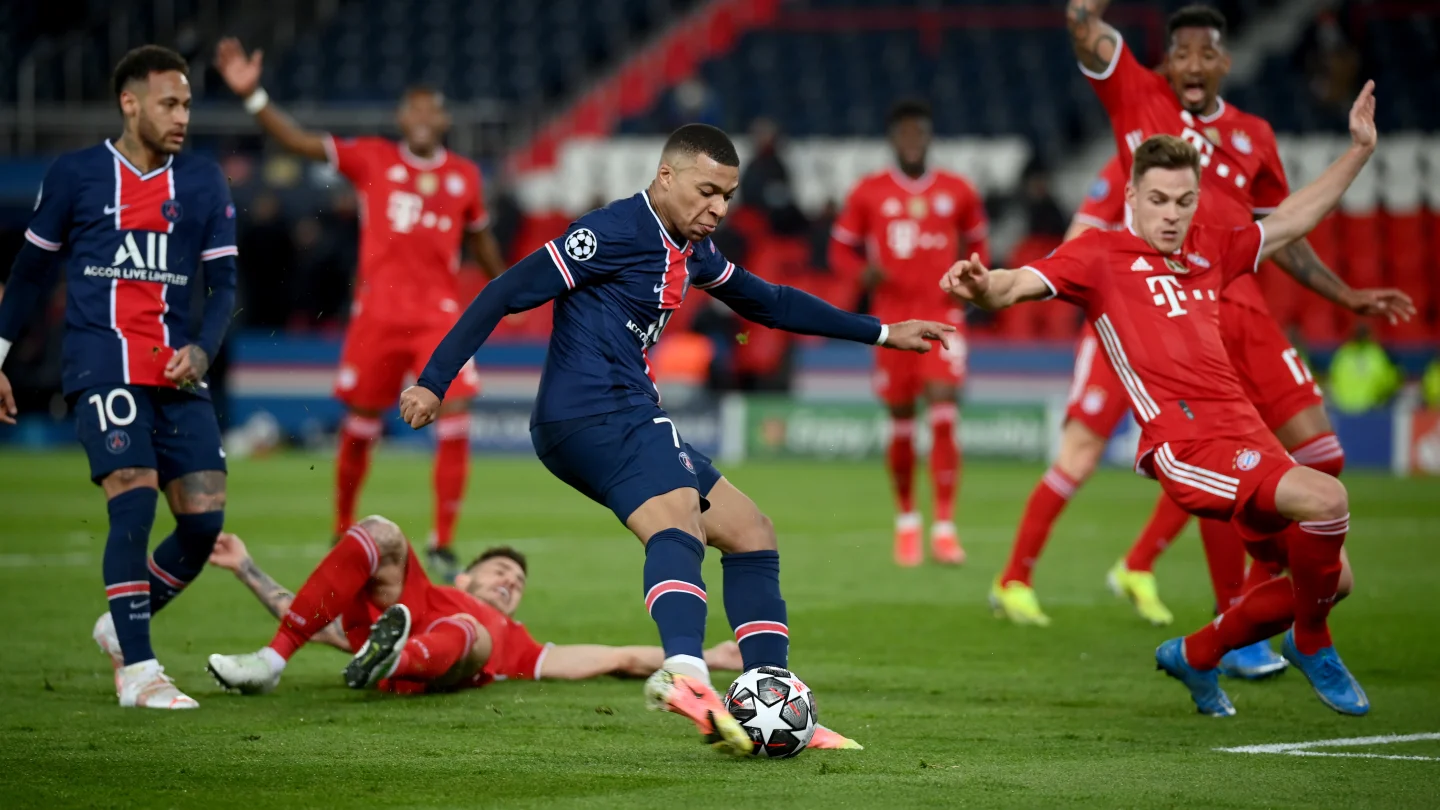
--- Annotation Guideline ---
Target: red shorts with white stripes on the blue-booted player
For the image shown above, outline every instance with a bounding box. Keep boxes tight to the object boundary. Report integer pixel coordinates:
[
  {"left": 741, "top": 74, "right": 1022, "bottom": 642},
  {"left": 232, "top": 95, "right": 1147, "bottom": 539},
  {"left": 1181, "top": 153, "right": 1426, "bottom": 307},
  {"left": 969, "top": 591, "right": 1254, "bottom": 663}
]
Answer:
[{"left": 1139, "top": 431, "right": 1297, "bottom": 542}]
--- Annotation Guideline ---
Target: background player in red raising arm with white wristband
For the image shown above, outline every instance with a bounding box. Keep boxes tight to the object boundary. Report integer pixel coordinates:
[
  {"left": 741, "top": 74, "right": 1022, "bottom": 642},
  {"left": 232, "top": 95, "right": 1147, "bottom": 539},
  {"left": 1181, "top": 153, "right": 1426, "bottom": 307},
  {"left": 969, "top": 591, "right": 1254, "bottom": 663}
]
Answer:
[{"left": 215, "top": 39, "right": 505, "bottom": 579}]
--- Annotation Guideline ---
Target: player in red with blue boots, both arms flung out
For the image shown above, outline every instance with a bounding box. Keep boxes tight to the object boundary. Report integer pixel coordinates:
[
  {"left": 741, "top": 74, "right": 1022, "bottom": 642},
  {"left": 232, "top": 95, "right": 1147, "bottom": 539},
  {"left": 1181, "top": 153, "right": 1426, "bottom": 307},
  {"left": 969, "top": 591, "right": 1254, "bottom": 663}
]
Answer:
[{"left": 940, "top": 82, "right": 1398, "bottom": 716}]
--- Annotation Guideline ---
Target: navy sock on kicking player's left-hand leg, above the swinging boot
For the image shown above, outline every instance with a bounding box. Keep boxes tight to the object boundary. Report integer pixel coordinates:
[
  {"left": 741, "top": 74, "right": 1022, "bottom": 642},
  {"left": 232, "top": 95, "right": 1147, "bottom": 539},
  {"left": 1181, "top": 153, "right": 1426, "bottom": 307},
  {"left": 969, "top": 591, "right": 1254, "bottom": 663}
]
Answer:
[{"left": 645, "top": 529, "right": 706, "bottom": 662}]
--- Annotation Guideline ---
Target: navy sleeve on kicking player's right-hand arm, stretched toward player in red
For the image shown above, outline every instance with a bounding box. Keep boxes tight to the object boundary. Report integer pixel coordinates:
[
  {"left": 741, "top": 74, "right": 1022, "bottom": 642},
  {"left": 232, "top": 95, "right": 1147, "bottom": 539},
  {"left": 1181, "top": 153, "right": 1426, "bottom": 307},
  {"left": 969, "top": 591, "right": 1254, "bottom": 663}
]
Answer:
[{"left": 694, "top": 239, "right": 880, "bottom": 343}]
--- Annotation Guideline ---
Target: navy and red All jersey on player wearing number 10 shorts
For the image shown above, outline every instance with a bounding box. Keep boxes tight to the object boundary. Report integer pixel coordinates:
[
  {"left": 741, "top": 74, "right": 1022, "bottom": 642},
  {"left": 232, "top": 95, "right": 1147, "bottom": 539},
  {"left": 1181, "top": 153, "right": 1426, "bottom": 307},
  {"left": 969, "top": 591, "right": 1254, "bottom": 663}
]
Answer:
[{"left": 24, "top": 141, "right": 236, "bottom": 395}]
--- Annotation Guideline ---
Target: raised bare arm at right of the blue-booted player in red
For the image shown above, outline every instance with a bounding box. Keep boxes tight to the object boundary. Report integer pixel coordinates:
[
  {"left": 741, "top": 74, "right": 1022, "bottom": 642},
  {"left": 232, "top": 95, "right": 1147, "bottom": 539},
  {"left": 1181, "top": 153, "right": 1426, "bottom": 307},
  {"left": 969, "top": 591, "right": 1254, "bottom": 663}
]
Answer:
[{"left": 1260, "top": 81, "right": 1378, "bottom": 259}]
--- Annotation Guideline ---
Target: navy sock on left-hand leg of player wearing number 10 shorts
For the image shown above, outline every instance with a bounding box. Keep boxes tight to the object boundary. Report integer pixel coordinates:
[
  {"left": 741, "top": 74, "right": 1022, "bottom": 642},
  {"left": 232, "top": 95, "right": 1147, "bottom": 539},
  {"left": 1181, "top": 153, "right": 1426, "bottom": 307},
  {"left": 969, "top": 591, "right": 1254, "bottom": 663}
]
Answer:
[{"left": 102, "top": 487, "right": 160, "bottom": 664}]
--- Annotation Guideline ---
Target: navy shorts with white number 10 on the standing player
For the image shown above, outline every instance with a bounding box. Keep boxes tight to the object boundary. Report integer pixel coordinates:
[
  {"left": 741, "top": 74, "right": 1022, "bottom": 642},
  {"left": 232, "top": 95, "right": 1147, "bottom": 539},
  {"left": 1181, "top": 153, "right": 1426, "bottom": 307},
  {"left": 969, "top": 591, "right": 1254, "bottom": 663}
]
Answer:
[{"left": 75, "top": 385, "right": 225, "bottom": 489}]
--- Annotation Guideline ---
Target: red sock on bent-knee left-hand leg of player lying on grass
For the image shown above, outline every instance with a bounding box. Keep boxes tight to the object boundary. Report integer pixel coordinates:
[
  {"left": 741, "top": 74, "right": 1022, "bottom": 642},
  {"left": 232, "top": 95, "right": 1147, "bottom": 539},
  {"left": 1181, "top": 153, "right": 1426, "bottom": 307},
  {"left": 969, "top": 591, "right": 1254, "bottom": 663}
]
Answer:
[{"left": 269, "top": 526, "right": 380, "bottom": 660}]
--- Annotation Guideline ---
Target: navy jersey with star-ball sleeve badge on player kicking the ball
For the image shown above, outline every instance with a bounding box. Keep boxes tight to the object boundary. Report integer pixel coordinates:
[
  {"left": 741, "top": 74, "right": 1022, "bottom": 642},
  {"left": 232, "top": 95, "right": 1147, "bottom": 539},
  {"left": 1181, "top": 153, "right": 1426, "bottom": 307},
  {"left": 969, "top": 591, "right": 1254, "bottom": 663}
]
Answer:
[{"left": 531, "top": 192, "right": 736, "bottom": 424}]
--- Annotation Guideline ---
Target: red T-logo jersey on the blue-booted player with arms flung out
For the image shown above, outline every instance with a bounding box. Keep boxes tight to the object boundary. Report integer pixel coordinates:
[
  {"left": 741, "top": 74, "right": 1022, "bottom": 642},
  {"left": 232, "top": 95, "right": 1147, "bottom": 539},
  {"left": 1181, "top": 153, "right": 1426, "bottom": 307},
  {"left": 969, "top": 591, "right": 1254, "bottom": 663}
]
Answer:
[{"left": 1027, "top": 222, "right": 1266, "bottom": 458}]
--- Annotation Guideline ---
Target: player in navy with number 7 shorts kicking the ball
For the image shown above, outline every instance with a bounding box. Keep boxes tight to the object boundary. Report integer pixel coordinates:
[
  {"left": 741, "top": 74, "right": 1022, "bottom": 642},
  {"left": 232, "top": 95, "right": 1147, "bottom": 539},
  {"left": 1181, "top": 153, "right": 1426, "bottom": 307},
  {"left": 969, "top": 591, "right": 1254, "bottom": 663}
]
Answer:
[{"left": 400, "top": 124, "right": 955, "bottom": 755}]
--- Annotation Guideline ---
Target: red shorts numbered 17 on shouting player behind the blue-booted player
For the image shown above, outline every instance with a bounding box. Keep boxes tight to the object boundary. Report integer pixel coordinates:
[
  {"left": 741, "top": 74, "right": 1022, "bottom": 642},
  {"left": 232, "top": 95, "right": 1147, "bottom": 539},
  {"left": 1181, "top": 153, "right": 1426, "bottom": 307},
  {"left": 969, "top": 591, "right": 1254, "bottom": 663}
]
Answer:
[{"left": 1220, "top": 300, "right": 1325, "bottom": 431}]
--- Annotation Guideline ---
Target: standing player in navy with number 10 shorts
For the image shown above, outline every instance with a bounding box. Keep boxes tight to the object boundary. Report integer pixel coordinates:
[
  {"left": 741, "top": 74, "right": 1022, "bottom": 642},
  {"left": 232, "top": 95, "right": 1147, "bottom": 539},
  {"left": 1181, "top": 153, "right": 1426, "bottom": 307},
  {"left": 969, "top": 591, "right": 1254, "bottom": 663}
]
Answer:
[{"left": 0, "top": 45, "right": 236, "bottom": 709}]
